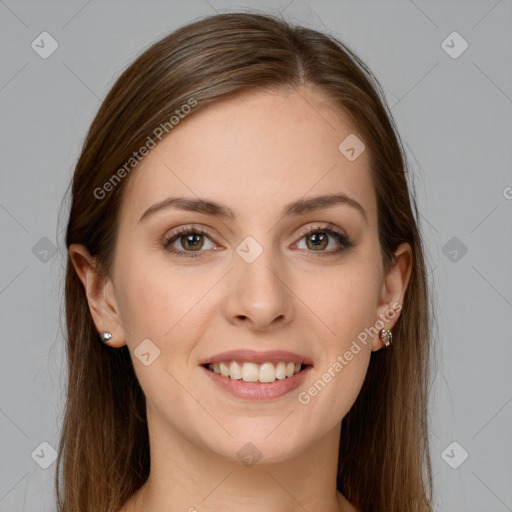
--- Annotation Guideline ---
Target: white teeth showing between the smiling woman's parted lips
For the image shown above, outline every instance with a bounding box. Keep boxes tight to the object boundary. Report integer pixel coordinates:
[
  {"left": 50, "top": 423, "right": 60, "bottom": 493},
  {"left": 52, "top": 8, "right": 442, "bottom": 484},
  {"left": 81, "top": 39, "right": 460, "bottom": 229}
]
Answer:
[{"left": 202, "top": 361, "right": 311, "bottom": 383}]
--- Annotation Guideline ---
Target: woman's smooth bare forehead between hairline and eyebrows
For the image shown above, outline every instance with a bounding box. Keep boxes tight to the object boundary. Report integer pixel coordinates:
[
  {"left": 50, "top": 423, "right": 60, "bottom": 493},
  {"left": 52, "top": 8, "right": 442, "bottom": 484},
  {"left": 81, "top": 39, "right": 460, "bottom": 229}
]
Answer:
[{"left": 121, "top": 87, "right": 376, "bottom": 222}]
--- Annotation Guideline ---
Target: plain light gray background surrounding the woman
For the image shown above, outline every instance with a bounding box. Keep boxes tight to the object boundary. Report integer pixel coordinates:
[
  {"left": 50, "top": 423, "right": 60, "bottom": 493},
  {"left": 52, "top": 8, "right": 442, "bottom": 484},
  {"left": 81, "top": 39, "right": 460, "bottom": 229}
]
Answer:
[{"left": 0, "top": 0, "right": 512, "bottom": 512}]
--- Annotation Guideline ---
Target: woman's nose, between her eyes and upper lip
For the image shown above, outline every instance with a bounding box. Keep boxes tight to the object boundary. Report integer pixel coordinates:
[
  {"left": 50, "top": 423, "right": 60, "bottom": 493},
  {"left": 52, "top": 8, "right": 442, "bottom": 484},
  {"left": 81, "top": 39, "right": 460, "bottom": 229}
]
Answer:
[{"left": 225, "top": 244, "right": 293, "bottom": 331}]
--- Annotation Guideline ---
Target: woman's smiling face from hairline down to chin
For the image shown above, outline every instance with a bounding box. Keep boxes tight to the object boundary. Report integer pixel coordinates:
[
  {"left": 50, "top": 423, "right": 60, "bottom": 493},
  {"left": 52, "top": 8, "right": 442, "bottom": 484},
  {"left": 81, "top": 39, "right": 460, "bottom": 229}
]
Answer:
[{"left": 87, "top": 88, "right": 405, "bottom": 462}]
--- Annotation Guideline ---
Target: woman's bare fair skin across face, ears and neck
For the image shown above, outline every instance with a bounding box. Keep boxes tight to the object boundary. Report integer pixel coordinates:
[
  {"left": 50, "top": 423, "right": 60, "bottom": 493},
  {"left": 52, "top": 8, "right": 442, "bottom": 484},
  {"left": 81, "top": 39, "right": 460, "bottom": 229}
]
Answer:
[{"left": 69, "top": 87, "right": 411, "bottom": 512}]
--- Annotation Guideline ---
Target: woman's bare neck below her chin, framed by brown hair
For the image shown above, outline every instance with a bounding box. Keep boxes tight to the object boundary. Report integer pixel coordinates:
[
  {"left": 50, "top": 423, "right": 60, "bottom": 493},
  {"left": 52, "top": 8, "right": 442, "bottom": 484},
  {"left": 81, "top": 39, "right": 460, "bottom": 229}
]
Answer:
[{"left": 122, "top": 406, "right": 356, "bottom": 512}]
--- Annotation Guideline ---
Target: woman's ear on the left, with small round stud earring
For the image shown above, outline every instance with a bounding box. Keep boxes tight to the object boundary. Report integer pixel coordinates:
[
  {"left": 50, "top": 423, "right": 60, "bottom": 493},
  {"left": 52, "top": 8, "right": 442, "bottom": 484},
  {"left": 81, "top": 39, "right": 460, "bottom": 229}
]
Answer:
[{"left": 69, "top": 244, "right": 126, "bottom": 348}]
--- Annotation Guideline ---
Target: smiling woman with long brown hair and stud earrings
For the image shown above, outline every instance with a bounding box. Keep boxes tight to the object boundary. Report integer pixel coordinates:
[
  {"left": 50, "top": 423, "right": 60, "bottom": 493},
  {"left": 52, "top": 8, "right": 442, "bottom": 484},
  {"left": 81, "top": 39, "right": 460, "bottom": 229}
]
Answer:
[{"left": 56, "top": 9, "right": 432, "bottom": 512}]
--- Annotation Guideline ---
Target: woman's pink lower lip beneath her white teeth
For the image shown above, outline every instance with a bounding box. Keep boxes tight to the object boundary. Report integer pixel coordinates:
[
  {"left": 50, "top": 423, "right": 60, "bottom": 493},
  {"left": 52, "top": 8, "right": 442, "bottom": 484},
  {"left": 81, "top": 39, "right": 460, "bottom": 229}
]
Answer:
[{"left": 201, "top": 366, "right": 312, "bottom": 400}]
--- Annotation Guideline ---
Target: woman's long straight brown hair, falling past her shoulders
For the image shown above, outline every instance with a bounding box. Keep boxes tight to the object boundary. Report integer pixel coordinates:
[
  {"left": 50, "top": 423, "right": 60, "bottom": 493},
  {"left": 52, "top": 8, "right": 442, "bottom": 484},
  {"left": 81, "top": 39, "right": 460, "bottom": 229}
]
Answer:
[{"left": 55, "top": 12, "right": 433, "bottom": 512}]
